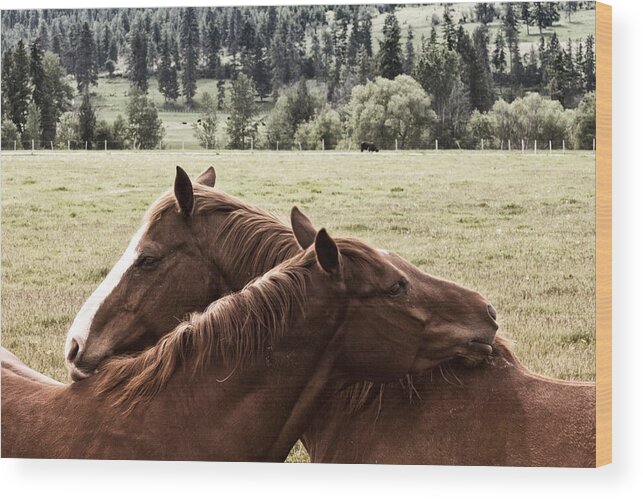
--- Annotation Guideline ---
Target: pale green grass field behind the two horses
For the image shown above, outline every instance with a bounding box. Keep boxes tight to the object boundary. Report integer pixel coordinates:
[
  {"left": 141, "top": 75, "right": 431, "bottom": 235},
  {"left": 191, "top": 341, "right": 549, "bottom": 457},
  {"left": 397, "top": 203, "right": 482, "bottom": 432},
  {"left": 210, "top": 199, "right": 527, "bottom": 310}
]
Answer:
[{"left": 1, "top": 152, "right": 595, "bottom": 460}]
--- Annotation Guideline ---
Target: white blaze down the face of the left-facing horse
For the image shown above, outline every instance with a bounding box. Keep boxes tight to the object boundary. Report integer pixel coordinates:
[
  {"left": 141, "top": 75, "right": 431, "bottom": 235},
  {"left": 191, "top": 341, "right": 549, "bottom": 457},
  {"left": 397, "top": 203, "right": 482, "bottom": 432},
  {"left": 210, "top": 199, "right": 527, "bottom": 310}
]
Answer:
[{"left": 65, "top": 224, "right": 147, "bottom": 359}]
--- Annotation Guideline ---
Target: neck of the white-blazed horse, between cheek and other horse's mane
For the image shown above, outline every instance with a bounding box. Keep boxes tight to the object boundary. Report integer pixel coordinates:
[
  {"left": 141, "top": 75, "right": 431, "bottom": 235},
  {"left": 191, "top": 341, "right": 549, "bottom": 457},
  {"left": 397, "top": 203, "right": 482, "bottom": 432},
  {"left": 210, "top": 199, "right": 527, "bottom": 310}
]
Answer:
[{"left": 201, "top": 210, "right": 301, "bottom": 291}]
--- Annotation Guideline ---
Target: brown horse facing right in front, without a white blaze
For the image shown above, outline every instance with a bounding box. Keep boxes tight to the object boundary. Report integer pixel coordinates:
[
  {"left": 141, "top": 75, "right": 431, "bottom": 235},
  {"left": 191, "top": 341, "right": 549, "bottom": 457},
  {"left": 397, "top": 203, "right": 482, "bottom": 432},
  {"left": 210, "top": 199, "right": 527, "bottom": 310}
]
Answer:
[{"left": 2, "top": 174, "right": 497, "bottom": 461}]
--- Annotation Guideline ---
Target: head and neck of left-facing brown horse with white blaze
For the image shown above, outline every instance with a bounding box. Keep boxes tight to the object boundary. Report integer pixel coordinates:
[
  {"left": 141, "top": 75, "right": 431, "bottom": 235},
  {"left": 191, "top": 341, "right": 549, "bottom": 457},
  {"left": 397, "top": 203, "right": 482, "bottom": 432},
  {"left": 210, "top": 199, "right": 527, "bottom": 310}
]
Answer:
[{"left": 65, "top": 167, "right": 300, "bottom": 380}]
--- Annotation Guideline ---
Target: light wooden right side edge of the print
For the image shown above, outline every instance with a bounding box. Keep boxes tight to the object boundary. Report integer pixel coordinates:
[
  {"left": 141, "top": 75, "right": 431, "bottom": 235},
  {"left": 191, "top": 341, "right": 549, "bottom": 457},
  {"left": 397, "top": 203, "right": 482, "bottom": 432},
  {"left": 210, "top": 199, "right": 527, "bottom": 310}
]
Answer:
[{"left": 596, "top": 2, "right": 612, "bottom": 466}]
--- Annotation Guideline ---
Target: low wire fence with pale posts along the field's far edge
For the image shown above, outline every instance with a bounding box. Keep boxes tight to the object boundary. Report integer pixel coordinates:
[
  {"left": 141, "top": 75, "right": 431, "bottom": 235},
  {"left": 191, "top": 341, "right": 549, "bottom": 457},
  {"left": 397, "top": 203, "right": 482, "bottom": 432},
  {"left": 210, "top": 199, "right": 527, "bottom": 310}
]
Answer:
[{"left": 0, "top": 138, "right": 596, "bottom": 153}]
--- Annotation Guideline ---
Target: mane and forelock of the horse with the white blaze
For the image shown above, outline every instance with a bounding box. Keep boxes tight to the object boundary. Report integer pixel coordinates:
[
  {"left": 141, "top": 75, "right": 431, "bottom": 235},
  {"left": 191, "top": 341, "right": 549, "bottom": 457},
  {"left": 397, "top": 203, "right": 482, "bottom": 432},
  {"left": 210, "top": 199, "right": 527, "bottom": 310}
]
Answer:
[{"left": 146, "top": 184, "right": 301, "bottom": 278}]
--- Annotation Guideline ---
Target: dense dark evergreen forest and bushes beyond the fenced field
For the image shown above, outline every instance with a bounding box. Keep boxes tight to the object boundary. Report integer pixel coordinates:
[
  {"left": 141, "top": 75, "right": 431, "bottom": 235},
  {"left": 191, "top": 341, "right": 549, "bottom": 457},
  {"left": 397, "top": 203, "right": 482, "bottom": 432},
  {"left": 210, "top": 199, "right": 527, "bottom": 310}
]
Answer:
[{"left": 2, "top": 2, "right": 596, "bottom": 147}]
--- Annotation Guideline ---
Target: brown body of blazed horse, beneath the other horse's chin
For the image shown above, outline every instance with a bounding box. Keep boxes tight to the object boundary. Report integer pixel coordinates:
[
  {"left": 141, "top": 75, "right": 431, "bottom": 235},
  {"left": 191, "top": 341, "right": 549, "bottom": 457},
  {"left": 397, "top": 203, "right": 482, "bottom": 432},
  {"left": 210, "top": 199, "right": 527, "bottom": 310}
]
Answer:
[{"left": 303, "top": 340, "right": 596, "bottom": 467}]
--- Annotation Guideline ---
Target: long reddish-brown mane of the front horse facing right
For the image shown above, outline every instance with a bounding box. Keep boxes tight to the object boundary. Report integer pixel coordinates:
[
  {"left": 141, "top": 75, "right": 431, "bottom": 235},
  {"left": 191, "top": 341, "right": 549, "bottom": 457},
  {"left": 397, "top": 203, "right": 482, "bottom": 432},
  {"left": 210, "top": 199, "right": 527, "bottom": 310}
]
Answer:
[{"left": 97, "top": 252, "right": 314, "bottom": 409}]
